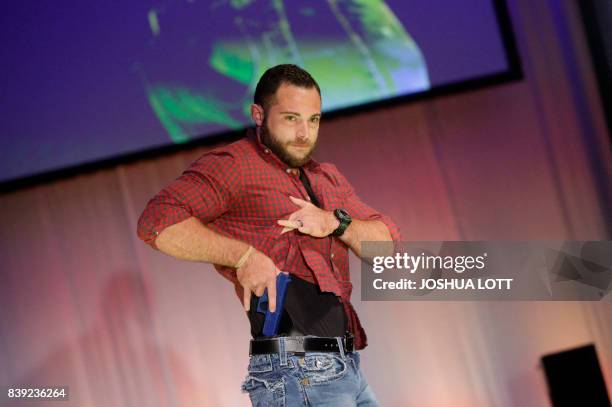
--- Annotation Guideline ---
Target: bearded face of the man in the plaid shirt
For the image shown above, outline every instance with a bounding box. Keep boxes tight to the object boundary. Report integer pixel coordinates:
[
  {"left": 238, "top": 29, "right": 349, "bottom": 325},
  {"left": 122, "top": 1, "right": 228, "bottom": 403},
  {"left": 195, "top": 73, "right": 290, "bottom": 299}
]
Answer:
[{"left": 255, "top": 84, "right": 321, "bottom": 168}]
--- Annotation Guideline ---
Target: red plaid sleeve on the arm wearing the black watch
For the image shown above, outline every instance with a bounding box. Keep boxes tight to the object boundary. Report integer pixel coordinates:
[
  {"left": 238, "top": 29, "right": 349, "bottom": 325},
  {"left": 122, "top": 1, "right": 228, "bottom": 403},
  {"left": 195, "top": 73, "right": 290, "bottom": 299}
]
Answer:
[{"left": 328, "top": 164, "right": 402, "bottom": 245}]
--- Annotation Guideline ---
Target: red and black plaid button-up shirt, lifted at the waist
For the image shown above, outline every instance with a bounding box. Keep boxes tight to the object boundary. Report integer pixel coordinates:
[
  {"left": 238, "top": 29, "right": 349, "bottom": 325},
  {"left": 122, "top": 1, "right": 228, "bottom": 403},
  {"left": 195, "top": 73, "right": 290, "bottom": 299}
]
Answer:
[{"left": 138, "top": 132, "right": 400, "bottom": 349}]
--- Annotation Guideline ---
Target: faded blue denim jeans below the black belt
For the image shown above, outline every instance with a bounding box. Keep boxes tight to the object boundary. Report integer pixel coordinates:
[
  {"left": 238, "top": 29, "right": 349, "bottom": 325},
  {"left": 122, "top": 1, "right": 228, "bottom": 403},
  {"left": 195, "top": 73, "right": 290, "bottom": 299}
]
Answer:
[{"left": 242, "top": 346, "right": 378, "bottom": 407}]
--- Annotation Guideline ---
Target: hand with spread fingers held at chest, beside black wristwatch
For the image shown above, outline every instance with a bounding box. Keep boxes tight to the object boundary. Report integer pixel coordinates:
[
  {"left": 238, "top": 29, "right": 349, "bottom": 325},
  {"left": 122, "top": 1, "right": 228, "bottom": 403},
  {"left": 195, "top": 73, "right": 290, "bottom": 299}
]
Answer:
[{"left": 276, "top": 196, "right": 340, "bottom": 237}]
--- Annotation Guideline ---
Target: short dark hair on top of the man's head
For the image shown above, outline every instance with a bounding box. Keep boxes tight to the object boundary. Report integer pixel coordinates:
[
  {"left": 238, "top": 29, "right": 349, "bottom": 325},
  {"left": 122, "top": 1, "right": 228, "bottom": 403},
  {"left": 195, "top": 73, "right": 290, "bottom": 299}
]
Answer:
[{"left": 254, "top": 64, "right": 321, "bottom": 110}]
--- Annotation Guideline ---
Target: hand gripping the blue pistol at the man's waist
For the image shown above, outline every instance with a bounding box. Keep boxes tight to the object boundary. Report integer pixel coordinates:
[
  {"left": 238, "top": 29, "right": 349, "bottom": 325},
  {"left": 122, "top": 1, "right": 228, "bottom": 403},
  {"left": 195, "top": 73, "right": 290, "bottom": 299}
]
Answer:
[{"left": 236, "top": 250, "right": 281, "bottom": 312}]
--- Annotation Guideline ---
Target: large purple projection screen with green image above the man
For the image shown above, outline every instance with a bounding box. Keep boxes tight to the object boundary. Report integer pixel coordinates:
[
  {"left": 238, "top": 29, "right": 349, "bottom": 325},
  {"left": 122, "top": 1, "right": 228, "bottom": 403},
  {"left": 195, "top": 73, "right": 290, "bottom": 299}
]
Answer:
[{"left": 0, "top": 0, "right": 515, "bottom": 183}]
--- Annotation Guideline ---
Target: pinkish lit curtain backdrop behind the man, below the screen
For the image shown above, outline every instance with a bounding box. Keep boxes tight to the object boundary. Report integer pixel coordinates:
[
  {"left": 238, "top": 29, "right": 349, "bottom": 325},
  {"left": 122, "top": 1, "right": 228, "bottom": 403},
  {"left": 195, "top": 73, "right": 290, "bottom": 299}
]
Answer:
[{"left": 0, "top": 0, "right": 612, "bottom": 407}]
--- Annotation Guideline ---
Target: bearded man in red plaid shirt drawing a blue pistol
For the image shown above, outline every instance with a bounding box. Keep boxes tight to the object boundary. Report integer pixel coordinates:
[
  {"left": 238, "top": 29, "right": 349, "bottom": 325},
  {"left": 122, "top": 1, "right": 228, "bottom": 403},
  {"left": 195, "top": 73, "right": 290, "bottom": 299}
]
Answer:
[{"left": 138, "top": 65, "right": 399, "bottom": 406}]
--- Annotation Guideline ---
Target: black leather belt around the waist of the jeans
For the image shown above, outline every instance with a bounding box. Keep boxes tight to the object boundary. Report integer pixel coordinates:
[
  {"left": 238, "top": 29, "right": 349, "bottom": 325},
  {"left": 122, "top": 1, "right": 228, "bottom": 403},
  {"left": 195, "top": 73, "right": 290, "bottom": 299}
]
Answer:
[{"left": 249, "top": 333, "right": 353, "bottom": 355}]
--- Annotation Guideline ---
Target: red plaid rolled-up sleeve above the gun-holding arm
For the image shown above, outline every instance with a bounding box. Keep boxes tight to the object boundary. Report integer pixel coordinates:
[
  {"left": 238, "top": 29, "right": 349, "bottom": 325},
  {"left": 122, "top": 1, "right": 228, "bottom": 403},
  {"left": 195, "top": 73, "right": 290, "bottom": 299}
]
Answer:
[{"left": 137, "top": 151, "right": 241, "bottom": 249}]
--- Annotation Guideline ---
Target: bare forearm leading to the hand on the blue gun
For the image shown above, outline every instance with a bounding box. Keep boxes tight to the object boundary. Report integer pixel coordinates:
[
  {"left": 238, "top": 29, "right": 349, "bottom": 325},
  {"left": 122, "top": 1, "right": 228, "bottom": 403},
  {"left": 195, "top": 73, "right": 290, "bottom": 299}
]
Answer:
[{"left": 155, "top": 217, "right": 249, "bottom": 267}]
